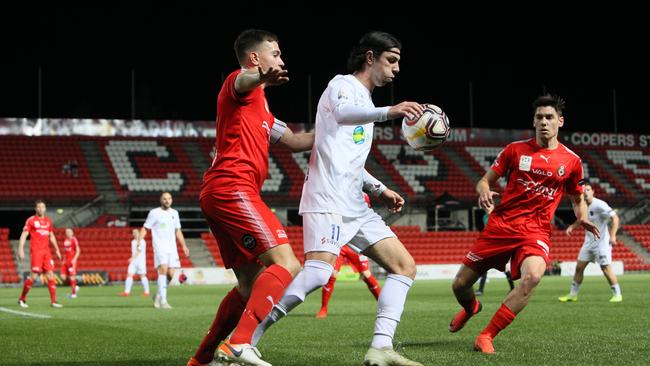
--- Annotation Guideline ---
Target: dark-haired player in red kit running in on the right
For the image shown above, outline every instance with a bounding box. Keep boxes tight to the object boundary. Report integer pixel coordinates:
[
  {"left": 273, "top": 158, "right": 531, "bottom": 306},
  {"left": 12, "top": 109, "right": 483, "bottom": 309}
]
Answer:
[{"left": 449, "top": 95, "right": 599, "bottom": 353}]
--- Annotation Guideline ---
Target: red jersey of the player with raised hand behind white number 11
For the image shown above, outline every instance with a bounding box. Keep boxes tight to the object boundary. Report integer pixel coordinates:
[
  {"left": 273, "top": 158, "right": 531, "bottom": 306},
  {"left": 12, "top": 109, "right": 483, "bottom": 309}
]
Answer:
[{"left": 201, "top": 70, "right": 275, "bottom": 197}]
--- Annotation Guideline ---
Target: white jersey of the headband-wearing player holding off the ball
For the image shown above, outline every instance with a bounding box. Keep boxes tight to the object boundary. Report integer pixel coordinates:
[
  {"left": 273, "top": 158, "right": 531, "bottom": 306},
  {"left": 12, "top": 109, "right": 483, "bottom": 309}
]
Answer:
[{"left": 299, "top": 75, "right": 390, "bottom": 217}]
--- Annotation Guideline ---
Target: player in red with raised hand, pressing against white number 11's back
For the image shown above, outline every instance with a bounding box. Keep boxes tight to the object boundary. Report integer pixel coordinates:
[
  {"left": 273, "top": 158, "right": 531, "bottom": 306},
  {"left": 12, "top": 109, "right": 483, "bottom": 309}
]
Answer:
[{"left": 188, "top": 29, "right": 314, "bottom": 365}]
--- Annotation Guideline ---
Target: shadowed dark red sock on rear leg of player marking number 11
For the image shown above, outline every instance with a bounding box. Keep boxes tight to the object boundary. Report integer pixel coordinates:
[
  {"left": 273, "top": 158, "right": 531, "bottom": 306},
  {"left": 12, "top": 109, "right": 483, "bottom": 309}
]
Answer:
[{"left": 194, "top": 288, "right": 246, "bottom": 364}]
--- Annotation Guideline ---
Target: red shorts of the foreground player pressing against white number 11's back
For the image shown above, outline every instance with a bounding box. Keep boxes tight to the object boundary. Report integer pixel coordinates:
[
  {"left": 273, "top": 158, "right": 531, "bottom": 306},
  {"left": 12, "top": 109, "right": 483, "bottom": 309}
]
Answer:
[{"left": 200, "top": 191, "right": 289, "bottom": 268}]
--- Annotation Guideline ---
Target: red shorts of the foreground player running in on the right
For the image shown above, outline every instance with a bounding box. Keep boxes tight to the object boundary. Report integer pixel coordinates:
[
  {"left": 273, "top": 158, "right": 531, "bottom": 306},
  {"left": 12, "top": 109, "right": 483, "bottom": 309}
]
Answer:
[{"left": 463, "top": 232, "right": 549, "bottom": 280}]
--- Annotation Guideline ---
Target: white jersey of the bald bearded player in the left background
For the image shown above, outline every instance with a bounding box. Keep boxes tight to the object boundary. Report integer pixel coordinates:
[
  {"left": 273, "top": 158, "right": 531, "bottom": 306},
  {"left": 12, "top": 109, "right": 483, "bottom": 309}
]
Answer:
[{"left": 144, "top": 207, "right": 181, "bottom": 253}]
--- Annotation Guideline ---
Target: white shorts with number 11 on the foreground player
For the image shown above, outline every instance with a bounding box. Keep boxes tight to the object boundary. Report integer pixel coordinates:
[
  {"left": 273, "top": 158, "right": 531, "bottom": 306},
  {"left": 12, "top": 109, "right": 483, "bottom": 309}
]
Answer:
[{"left": 302, "top": 209, "right": 395, "bottom": 256}]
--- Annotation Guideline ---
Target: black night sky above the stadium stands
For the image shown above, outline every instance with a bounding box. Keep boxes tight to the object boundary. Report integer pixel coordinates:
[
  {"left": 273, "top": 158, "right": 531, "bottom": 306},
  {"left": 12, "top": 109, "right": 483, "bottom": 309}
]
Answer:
[{"left": 0, "top": 1, "right": 650, "bottom": 133}]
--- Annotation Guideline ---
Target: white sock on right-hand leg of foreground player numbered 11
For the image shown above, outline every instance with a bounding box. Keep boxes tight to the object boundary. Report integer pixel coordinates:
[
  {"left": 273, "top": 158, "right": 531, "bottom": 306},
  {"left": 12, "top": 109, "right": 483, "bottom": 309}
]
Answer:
[{"left": 370, "top": 274, "right": 413, "bottom": 349}]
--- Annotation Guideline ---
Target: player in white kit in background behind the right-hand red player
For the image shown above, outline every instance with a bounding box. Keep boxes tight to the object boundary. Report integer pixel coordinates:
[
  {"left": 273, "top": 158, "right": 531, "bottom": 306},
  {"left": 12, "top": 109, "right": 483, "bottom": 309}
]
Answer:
[{"left": 558, "top": 184, "right": 623, "bottom": 302}]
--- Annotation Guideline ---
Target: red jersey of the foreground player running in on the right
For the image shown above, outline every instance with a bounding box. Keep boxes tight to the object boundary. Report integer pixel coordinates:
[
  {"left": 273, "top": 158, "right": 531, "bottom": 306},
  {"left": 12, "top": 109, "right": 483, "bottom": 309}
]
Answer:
[{"left": 485, "top": 138, "right": 584, "bottom": 238}]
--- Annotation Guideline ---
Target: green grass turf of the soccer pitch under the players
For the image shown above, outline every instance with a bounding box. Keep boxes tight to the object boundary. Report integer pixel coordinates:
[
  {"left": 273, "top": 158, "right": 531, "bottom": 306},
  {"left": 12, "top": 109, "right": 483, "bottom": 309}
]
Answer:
[{"left": 0, "top": 274, "right": 650, "bottom": 366}]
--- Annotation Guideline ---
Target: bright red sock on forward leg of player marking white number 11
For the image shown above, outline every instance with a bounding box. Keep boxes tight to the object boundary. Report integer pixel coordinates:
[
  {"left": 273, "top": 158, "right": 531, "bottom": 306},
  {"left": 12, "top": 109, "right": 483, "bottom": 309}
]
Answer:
[{"left": 230, "top": 264, "right": 293, "bottom": 344}]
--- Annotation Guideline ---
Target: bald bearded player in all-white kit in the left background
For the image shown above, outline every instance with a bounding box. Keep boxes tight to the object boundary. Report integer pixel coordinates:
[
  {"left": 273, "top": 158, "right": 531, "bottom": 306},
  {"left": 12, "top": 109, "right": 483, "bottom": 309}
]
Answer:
[{"left": 140, "top": 192, "right": 190, "bottom": 309}]
